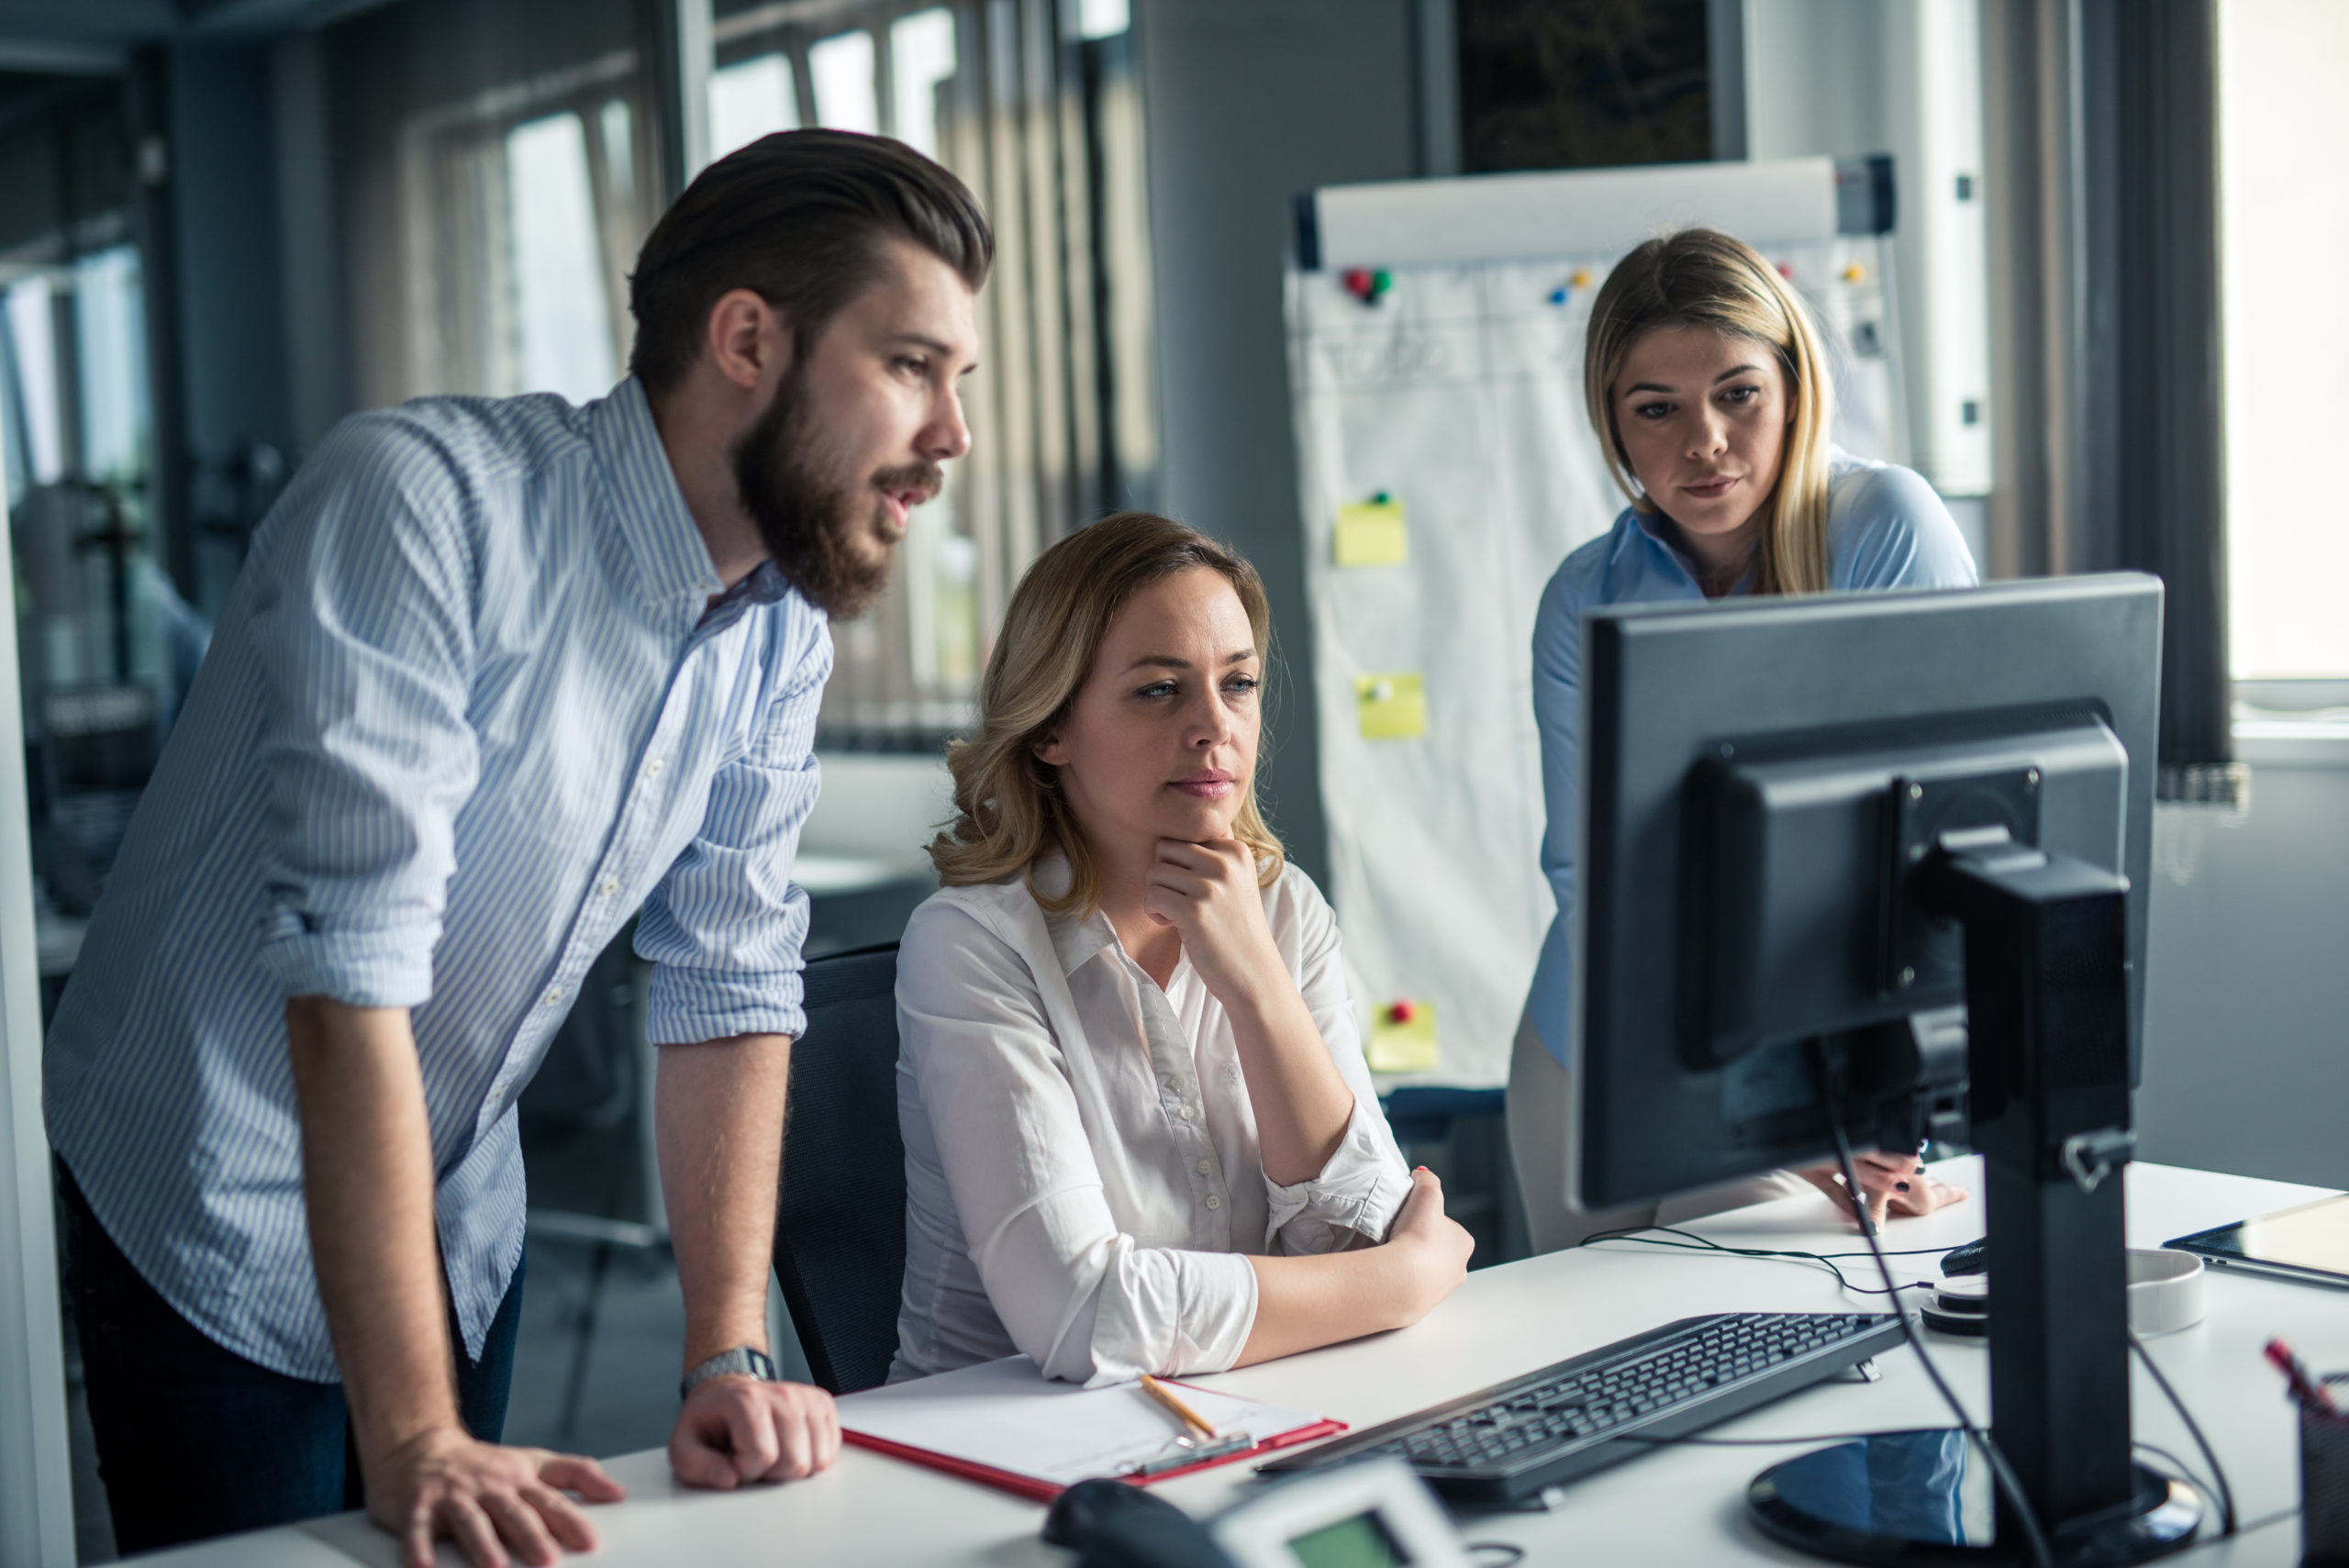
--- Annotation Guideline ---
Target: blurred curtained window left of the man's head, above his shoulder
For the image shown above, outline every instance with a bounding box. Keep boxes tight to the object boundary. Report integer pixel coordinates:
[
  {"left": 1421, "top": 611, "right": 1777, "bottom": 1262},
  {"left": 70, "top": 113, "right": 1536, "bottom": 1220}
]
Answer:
[{"left": 315, "top": 0, "right": 662, "bottom": 408}]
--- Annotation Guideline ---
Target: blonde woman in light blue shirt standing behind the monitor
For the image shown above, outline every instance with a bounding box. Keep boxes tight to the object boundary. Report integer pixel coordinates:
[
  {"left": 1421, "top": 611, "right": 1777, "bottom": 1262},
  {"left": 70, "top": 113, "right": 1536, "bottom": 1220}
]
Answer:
[{"left": 1508, "top": 228, "right": 1976, "bottom": 1251}]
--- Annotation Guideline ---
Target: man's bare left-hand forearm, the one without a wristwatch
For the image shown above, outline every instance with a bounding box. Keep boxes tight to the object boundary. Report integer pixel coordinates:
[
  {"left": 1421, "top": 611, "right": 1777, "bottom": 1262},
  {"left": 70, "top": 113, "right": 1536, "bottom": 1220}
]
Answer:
[{"left": 286, "top": 995, "right": 458, "bottom": 1460}]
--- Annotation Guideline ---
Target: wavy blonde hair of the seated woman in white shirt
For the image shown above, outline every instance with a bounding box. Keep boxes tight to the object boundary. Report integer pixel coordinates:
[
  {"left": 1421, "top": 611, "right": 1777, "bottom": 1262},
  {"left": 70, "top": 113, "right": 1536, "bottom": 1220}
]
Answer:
[{"left": 930, "top": 512, "right": 1283, "bottom": 916}]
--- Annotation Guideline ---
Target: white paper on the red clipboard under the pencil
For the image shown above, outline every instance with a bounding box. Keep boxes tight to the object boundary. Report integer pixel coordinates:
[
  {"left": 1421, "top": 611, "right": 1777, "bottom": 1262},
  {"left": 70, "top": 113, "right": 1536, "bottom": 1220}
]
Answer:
[{"left": 841, "top": 1357, "right": 1322, "bottom": 1485}]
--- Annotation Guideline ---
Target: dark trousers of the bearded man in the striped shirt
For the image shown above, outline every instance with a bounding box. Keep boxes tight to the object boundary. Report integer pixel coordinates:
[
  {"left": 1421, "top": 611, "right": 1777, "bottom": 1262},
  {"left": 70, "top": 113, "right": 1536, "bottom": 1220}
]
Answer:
[{"left": 56, "top": 1162, "right": 521, "bottom": 1556}]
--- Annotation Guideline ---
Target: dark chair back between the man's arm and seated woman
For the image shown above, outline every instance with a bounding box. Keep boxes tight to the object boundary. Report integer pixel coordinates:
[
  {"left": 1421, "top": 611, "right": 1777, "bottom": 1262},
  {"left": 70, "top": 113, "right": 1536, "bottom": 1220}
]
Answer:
[{"left": 775, "top": 941, "right": 905, "bottom": 1395}]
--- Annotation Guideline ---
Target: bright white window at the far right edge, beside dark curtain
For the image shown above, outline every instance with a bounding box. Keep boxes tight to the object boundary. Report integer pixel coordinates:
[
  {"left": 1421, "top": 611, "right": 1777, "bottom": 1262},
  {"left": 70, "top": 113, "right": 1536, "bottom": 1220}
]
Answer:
[{"left": 2218, "top": 0, "right": 2349, "bottom": 681}]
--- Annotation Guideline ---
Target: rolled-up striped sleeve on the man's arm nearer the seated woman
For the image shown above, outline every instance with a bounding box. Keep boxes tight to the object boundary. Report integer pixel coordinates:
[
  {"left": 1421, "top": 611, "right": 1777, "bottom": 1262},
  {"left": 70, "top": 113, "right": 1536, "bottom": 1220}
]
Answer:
[{"left": 637, "top": 625, "right": 831, "bottom": 1044}]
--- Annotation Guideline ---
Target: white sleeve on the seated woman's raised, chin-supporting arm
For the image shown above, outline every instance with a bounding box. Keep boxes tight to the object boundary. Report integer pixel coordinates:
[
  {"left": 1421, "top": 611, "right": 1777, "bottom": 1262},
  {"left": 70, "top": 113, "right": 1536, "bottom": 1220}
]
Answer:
[{"left": 1264, "top": 878, "right": 1412, "bottom": 1253}]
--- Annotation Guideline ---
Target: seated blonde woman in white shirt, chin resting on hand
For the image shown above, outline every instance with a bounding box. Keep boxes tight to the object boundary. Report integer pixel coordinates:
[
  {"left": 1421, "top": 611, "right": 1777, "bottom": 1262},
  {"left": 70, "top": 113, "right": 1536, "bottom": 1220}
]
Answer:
[{"left": 890, "top": 512, "right": 1471, "bottom": 1383}]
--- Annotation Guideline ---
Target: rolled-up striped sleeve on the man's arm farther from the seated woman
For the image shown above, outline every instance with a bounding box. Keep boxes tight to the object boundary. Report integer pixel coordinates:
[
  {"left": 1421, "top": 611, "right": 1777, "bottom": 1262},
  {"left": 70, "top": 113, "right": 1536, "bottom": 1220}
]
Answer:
[{"left": 244, "top": 416, "right": 479, "bottom": 1007}]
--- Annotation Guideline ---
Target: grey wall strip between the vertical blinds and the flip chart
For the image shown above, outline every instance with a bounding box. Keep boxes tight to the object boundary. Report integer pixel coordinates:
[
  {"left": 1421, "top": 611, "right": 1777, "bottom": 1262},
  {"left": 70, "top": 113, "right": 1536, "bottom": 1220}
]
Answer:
[{"left": 1134, "top": 0, "right": 1419, "bottom": 878}]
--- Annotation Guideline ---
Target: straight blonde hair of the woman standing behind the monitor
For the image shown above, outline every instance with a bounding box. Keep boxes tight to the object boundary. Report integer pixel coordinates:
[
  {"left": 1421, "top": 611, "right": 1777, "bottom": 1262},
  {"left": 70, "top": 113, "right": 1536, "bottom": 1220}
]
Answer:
[{"left": 1583, "top": 228, "right": 1834, "bottom": 594}]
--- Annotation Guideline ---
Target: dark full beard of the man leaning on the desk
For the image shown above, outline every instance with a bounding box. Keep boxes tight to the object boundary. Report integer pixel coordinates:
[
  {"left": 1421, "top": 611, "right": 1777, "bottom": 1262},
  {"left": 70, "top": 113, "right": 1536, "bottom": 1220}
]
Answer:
[{"left": 733, "top": 369, "right": 944, "bottom": 619}]
